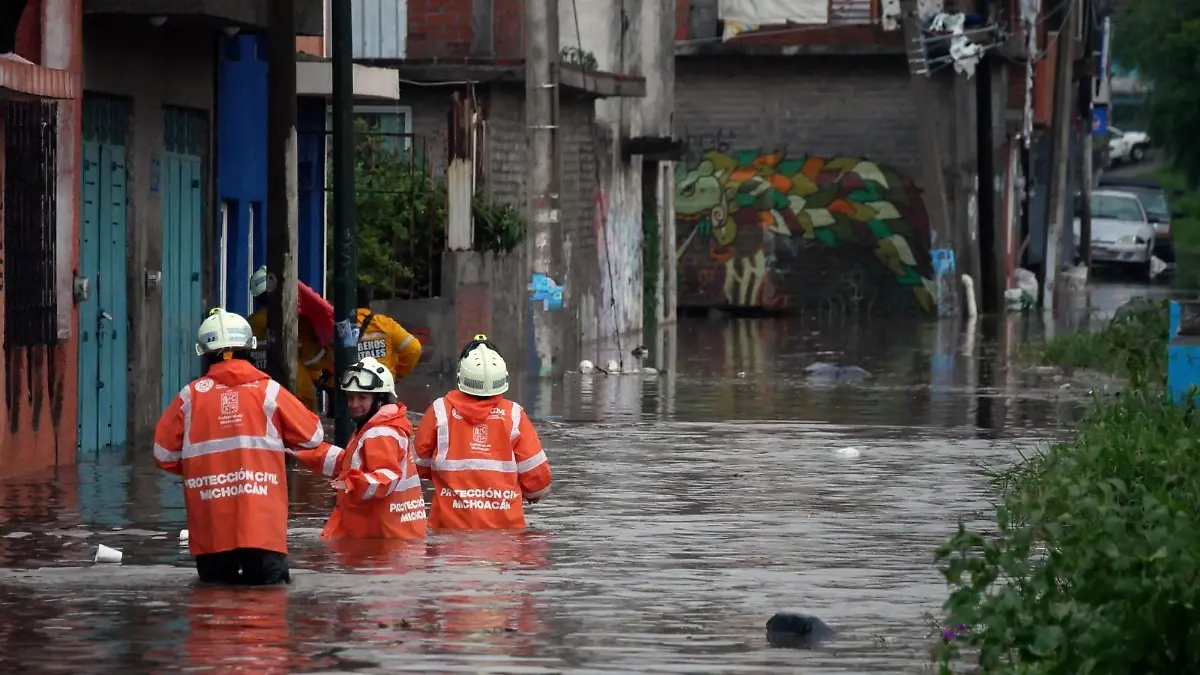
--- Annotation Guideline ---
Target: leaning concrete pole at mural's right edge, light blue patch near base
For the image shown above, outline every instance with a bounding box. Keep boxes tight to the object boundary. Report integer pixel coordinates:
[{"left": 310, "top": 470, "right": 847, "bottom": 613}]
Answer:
[{"left": 900, "top": 0, "right": 959, "bottom": 316}]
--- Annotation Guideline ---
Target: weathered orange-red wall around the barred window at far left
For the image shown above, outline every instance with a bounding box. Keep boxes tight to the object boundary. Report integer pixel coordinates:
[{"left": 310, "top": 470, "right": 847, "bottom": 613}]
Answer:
[{"left": 0, "top": 0, "right": 83, "bottom": 478}]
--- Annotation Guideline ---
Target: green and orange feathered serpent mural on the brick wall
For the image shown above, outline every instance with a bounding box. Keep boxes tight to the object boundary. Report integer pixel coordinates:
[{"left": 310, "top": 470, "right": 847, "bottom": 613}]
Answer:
[{"left": 674, "top": 150, "right": 937, "bottom": 313}]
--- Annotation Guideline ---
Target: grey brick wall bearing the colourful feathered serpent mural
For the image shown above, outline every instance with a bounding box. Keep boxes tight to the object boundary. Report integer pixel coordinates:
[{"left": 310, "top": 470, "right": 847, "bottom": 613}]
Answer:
[{"left": 674, "top": 56, "right": 950, "bottom": 313}]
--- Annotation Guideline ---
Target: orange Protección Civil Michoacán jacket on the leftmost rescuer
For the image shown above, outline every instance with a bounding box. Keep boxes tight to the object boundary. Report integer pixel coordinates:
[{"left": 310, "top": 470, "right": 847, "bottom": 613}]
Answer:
[{"left": 154, "top": 359, "right": 331, "bottom": 556}]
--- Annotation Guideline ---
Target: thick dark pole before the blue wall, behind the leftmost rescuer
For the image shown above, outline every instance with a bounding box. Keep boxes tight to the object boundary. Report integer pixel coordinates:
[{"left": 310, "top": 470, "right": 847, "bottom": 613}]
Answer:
[{"left": 266, "top": 0, "right": 299, "bottom": 392}]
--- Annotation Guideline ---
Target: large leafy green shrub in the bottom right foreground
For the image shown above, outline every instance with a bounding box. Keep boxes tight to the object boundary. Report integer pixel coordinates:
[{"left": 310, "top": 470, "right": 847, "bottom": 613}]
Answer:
[{"left": 937, "top": 392, "right": 1200, "bottom": 675}]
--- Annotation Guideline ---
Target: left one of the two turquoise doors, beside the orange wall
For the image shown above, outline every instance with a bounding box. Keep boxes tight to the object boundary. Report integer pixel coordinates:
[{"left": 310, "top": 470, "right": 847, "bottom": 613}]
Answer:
[{"left": 78, "top": 96, "right": 128, "bottom": 450}]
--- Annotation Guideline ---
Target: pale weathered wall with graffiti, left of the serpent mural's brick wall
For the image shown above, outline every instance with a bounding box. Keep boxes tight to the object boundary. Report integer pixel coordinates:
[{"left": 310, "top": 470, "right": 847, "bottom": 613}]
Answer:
[{"left": 559, "top": 0, "right": 674, "bottom": 364}]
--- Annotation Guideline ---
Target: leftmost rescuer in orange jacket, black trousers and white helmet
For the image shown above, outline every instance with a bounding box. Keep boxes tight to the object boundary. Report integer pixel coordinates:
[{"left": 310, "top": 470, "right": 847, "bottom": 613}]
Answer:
[{"left": 154, "top": 307, "right": 332, "bottom": 585}]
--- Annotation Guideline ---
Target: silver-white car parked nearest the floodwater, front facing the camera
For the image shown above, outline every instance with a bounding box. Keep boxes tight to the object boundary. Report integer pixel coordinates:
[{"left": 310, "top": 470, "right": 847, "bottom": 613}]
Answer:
[{"left": 1075, "top": 190, "right": 1154, "bottom": 281}]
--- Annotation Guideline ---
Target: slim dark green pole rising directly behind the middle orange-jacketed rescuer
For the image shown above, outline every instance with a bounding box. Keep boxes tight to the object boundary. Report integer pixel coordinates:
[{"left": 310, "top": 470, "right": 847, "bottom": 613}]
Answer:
[{"left": 330, "top": 0, "right": 359, "bottom": 447}]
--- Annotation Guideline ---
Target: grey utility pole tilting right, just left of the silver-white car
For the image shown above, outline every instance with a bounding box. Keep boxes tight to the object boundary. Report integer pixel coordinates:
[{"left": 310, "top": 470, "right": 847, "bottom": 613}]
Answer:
[{"left": 1042, "top": 0, "right": 1081, "bottom": 311}]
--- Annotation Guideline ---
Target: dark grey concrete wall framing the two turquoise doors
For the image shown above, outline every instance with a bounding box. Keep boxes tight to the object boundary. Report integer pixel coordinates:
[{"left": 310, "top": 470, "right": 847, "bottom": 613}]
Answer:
[{"left": 84, "top": 18, "right": 217, "bottom": 438}]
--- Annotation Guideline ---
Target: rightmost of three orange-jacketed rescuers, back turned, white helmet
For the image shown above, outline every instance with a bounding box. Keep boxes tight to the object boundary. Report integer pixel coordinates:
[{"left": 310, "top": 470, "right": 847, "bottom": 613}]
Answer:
[{"left": 416, "top": 335, "right": 550, "bottom": 530}]
